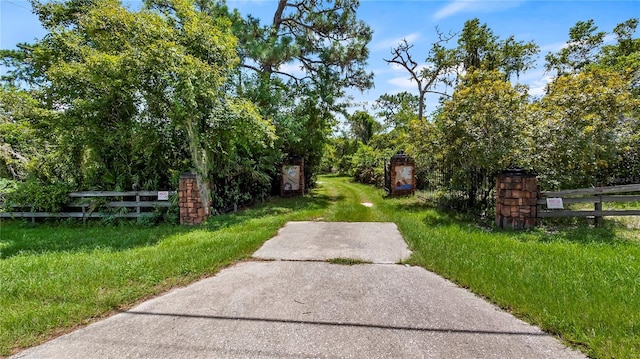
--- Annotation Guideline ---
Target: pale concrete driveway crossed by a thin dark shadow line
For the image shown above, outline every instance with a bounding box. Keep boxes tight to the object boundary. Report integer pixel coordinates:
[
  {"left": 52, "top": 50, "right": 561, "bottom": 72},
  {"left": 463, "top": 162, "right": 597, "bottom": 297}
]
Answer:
[{"left": 15, "top": 222, "right": 585, "bottom": 358}]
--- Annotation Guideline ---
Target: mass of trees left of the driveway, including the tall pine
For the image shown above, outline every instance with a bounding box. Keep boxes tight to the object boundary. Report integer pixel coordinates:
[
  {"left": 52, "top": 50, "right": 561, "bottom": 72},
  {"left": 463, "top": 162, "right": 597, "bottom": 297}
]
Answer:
[{"left": 0, "top": 0, "right": 372, "bottom": 214}]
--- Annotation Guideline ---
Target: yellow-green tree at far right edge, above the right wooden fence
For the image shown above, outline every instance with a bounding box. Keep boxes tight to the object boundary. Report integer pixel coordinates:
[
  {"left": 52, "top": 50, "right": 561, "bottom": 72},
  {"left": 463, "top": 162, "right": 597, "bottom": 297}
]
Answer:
[{"left": 536, "top": 68, "right": 640, "bottom": 188}]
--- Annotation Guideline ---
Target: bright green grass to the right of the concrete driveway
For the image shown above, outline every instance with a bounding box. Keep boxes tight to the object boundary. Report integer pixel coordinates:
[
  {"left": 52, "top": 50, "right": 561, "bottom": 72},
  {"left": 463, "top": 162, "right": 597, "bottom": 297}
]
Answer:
[{"left": 318, "top": 178, "right": 640, "bottom": 358}]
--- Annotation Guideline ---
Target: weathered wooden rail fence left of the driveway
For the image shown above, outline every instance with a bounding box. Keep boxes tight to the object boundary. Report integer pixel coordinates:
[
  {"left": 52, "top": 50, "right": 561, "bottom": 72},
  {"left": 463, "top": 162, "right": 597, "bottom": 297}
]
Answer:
[{"left": 0, "top": 191, "right": 176, "bottom": 222}]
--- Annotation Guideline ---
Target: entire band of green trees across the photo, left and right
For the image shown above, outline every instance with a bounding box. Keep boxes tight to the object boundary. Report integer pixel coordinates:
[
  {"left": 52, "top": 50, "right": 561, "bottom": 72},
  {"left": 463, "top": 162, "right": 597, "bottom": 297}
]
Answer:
[{"left": 0, "top": 0, "right": 640, "bottom": 217}]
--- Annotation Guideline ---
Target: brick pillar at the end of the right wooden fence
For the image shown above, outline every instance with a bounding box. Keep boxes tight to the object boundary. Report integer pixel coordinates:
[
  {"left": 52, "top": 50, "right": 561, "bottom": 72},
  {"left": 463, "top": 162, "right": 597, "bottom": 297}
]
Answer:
[{"left": 496, "top": 170, "right": 538, "bottom": 230}]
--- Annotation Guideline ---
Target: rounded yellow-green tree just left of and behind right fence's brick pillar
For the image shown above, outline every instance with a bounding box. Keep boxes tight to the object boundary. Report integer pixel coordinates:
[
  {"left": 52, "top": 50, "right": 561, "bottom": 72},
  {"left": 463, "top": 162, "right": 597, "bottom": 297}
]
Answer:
[{"left": 435, "top": 70, "right": 530, "bottom": 172}]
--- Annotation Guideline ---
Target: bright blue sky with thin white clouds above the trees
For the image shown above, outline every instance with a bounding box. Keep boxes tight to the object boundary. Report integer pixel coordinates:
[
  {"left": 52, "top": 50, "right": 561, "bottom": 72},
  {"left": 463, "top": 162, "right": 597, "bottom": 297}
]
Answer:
[{"left": 0, "top": 0, "right": 640, "bottom": 112}]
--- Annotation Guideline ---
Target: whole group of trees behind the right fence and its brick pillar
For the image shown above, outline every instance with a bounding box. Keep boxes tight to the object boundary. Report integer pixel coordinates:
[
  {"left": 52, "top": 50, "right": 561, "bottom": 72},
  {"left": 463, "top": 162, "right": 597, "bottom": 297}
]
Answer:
[{"left": 388, "top": 19, "right": 640, "bottom": 208}]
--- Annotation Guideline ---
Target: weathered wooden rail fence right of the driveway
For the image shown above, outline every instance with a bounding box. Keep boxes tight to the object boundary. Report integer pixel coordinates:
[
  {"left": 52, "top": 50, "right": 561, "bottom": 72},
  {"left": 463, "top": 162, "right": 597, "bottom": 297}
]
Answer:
[{"left": 537, "top": 184, "right": 640, "bottom": 225}]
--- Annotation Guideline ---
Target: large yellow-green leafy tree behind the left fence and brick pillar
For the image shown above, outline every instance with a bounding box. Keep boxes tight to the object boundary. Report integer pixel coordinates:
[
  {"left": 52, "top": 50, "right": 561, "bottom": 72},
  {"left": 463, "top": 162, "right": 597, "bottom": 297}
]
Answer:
[{"left": 0, "top": 0, "right": 274, "bottom": 211}]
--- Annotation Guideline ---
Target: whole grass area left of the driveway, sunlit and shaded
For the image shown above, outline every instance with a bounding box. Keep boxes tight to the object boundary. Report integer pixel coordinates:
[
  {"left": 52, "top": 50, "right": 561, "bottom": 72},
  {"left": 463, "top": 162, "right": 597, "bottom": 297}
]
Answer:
[{"left": 0, "top": 190, "right": 332, "bottom": 356}]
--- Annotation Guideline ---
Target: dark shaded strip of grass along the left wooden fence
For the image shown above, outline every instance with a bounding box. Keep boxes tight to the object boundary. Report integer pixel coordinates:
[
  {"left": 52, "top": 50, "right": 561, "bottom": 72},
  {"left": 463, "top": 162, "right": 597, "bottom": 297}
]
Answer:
[{"left": 0, "top": 193, "right": 336, "bottom": 260}]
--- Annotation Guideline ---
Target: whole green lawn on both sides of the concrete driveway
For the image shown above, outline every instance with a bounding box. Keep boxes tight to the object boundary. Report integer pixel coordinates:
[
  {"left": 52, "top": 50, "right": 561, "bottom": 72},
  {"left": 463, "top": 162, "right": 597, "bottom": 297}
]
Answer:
[{"left": 0, "top": 176, "right": 640, "bottom": 358}]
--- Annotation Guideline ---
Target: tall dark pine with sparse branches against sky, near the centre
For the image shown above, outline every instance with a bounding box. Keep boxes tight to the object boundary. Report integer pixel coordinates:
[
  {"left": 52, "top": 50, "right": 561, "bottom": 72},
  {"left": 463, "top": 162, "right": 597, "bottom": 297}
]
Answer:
[{"left": 215, "top": 0, "right": 373, "bottom": 186}]
